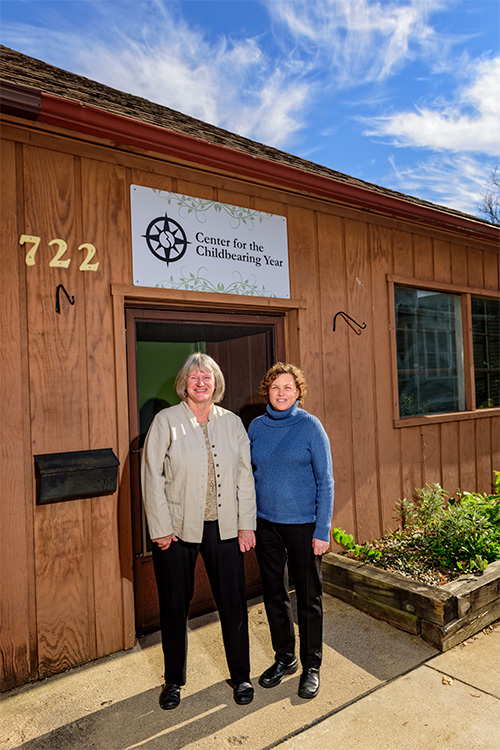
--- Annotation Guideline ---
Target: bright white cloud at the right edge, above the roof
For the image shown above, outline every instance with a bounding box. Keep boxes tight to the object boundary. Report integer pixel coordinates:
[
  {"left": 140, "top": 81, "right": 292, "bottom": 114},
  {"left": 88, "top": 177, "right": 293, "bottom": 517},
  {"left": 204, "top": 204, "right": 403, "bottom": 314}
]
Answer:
[{"left": 365, "top": 57, "right": 500, "bottom": 158}]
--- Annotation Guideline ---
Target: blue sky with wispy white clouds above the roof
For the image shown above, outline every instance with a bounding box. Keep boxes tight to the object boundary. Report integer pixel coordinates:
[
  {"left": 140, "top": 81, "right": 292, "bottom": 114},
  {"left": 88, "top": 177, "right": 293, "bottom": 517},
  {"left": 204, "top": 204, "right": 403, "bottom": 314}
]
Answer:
[{"left": 0, "top": 0, "right": 500, "bottom": 214}]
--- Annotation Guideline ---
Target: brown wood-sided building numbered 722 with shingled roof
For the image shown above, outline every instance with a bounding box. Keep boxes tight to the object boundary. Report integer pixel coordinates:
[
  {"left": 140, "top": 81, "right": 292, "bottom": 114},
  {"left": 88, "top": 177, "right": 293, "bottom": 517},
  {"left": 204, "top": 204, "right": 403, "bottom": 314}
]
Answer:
[{"left": 0, "top": 48, "right": 500, "bottom": 689}]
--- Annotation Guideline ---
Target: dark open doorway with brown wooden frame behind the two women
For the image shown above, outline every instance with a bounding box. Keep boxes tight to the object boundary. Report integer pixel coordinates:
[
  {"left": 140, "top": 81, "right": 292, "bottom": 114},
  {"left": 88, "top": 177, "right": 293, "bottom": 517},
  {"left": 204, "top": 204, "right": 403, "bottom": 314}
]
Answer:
[{"left": 126, "top": 308, "right": 284, "bottom": 634}]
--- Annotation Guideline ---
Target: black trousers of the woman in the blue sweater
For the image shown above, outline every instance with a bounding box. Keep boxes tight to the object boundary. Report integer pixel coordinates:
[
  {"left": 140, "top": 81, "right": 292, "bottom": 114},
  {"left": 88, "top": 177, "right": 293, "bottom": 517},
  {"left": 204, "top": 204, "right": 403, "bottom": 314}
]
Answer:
[{"left": 256, "top": 518, "right": 323, "bottom": 669}]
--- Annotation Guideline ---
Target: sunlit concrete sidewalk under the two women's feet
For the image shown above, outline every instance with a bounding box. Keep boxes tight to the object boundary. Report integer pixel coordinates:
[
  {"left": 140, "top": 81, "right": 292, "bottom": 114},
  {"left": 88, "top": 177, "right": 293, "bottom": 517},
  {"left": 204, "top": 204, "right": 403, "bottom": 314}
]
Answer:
[{"left": 0, "top": 594, "right": 500, "bottom": 750}]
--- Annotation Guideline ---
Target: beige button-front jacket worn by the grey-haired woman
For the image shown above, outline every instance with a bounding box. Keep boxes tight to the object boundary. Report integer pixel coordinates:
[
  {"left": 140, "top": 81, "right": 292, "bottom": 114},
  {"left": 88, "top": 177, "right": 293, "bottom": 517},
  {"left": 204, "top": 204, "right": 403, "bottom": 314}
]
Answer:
[{"left": 141, "top": 401, "right": 256, "bottom": 543}]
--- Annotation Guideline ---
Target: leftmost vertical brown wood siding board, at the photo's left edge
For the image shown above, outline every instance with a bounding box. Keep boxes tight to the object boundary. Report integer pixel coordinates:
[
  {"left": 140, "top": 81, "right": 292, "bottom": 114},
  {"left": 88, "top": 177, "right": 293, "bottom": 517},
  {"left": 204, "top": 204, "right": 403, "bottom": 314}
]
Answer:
[{"left": 0, "top": 142, "right": 36, "bottom": 689}]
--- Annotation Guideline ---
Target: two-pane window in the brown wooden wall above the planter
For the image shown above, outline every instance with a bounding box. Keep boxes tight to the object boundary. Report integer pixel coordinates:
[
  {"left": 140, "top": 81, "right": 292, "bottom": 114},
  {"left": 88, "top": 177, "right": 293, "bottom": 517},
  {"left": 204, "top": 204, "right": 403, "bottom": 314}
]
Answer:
[{"left": 394, "top": 285, "right": 500, "bottom": 418}]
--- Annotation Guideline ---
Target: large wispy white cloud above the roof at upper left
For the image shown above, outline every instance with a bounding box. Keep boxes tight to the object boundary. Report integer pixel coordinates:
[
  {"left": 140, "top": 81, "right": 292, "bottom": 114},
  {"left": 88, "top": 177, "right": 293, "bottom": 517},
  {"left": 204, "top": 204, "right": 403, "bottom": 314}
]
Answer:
[{"left": 0, "top": 1, "right": 313, "bottom": 148}]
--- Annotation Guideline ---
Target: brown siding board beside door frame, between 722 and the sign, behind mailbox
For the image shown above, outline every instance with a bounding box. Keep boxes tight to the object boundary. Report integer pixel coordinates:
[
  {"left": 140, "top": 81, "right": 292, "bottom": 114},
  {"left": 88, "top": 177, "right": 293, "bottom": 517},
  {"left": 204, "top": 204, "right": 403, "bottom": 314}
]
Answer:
[{"left": 81, "top": 159, "right": 131, "bottom": 656}]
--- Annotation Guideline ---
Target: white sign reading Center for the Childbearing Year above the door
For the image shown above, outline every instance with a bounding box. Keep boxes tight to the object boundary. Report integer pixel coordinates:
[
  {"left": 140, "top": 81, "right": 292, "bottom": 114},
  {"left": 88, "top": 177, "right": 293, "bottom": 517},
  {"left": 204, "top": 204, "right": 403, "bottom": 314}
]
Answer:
[{"left": 130, "top": 185, "right": 290, "bottom": 298}]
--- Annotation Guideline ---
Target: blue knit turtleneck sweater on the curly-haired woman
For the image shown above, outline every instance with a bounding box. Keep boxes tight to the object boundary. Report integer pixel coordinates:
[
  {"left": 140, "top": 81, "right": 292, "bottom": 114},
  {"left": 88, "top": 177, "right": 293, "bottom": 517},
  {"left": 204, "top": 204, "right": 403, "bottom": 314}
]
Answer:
[{"left": 248, "top": 402, "right": 333, "bottom": 541}]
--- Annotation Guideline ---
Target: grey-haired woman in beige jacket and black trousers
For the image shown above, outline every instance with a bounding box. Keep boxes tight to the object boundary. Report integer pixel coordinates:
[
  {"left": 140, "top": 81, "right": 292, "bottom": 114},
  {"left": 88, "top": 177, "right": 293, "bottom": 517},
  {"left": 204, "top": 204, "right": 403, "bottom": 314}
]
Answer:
[{"left": 142, "top": 352, "right": 256, "bottom": 709}]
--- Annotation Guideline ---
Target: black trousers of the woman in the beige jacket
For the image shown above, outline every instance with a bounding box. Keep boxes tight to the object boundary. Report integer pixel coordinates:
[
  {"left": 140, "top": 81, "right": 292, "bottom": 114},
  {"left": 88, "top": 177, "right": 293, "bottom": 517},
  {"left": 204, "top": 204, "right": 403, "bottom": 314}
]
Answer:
[{"left": 149, "top": 521, "right": 250, "bottom": 685}]
